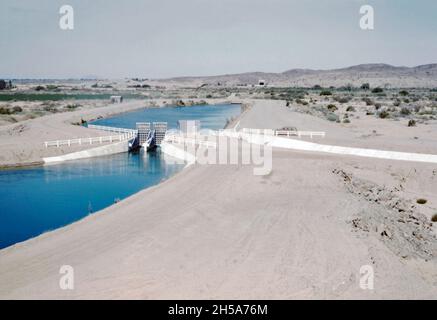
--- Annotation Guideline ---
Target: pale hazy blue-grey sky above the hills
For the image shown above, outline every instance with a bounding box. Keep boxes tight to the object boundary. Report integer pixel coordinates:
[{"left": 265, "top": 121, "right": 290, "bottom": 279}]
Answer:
[{"left": 0, "top": 0, "right": 437, "bottom": 78}]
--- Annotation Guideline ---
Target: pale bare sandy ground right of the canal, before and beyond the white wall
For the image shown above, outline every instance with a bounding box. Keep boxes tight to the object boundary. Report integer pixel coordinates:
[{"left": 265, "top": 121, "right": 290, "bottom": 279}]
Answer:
[{"left": 0, "top": 101, "right": 437, "bottom": 299}]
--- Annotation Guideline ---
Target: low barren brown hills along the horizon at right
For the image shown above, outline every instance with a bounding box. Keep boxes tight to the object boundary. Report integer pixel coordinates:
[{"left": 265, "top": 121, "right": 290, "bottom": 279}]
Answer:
[{"left": 159, "top": 64, "right": 437, "bottom": 88}]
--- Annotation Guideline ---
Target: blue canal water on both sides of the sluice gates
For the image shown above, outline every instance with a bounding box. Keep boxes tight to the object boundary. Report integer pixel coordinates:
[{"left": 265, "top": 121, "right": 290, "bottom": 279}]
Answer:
[{"left": 0, "top": 105, "right": 241, "bottom": 248}]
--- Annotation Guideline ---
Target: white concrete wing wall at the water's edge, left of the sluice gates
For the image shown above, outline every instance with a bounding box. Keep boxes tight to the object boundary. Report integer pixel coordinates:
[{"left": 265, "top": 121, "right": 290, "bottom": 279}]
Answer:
[{"left": 43, "top": 140, "right": 129, "bottom": 164}]
